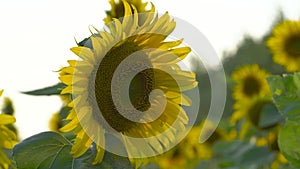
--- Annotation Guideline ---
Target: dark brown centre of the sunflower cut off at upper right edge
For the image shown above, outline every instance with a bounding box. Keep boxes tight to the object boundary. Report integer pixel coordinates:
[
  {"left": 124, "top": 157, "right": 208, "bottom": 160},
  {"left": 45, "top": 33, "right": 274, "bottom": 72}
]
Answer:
[{"left": 285, "top": 35, "right": 300, "bottom": 58}]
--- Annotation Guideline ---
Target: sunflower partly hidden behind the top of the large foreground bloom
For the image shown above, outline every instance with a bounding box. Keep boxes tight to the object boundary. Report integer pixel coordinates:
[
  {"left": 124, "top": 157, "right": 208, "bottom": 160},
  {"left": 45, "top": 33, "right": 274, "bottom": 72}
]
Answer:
[{"left": 104, "top": 0, "right": 149, "bottom": 25}]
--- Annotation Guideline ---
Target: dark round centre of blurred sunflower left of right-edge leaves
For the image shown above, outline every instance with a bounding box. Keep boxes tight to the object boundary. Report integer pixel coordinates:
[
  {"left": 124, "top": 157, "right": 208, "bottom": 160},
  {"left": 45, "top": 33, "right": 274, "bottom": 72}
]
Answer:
[{"left": 243, "top": 76, "right": 261, "bottom": 97}]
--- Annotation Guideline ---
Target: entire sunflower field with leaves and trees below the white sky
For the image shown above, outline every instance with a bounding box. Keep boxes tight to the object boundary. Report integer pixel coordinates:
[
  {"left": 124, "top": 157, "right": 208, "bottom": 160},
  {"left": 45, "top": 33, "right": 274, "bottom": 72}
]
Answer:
[{"left": 0, "top": 0, "right": 300, "bottom": 169}]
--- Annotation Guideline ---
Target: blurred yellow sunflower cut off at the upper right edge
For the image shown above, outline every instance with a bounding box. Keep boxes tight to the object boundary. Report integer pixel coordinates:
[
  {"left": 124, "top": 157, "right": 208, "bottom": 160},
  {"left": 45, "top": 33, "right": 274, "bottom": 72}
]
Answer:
[{"left": 267, "top": 20, "right": 300, "bottom": 72}]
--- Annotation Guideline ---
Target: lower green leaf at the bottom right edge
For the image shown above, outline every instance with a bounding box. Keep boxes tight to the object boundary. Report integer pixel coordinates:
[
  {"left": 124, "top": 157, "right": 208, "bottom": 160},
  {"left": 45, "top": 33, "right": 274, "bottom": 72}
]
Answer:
[{"left": 278, "top": 121, "right": 300, "bottom": 167}]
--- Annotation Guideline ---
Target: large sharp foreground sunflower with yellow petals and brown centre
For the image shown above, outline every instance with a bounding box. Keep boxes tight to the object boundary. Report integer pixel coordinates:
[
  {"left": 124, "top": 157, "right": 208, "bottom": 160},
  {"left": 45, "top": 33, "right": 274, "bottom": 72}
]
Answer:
[{"left": 59, "top": 1, "right": 198, "bottom": 164}]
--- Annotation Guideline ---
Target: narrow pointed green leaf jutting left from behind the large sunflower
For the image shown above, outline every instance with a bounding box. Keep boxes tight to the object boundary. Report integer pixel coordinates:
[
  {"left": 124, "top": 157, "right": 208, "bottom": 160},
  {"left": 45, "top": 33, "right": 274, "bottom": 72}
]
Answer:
[{"left": 22, "top": 83, "right": 66, "bottom": 96}]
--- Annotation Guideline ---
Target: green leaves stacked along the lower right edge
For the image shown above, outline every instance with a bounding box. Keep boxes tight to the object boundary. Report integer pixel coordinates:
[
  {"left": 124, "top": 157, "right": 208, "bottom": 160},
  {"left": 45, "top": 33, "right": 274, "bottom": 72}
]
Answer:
[{"left": 268, "top": 73, "right": 300, "bottom": 167}]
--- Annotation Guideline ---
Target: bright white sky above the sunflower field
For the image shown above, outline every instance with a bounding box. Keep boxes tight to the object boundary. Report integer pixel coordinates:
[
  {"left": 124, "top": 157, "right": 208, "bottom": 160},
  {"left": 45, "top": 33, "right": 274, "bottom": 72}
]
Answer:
[{"left": 0, "top": 0, "right": 300, "bottom": 139}]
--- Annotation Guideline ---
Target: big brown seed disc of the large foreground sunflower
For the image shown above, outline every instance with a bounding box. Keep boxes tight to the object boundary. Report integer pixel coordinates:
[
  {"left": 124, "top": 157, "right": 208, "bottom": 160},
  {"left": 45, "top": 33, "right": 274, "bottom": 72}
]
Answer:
[{"left": 93, "top": 39, "right": 154, "bottom": 132}]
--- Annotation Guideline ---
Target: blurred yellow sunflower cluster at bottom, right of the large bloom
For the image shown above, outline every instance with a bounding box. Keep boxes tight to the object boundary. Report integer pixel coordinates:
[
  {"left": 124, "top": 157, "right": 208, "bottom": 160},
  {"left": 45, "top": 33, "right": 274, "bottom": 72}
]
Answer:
[{"left": 154, "top": 120, "right": 236, "bottom": 169}]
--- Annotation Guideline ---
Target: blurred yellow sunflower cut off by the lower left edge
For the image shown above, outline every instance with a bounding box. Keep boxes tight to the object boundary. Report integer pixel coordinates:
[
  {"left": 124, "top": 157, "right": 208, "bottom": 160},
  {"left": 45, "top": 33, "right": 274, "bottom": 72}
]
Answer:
[{"left": 0, "top": 90, "right": 17, "bottom": 169}]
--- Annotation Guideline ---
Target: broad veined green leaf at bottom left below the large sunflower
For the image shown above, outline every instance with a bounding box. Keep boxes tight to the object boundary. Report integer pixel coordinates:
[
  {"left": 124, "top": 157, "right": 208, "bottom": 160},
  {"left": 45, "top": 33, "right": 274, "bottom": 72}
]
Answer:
[{"left": 13, "top": 132, "right": 93, "bottom": 169}]
